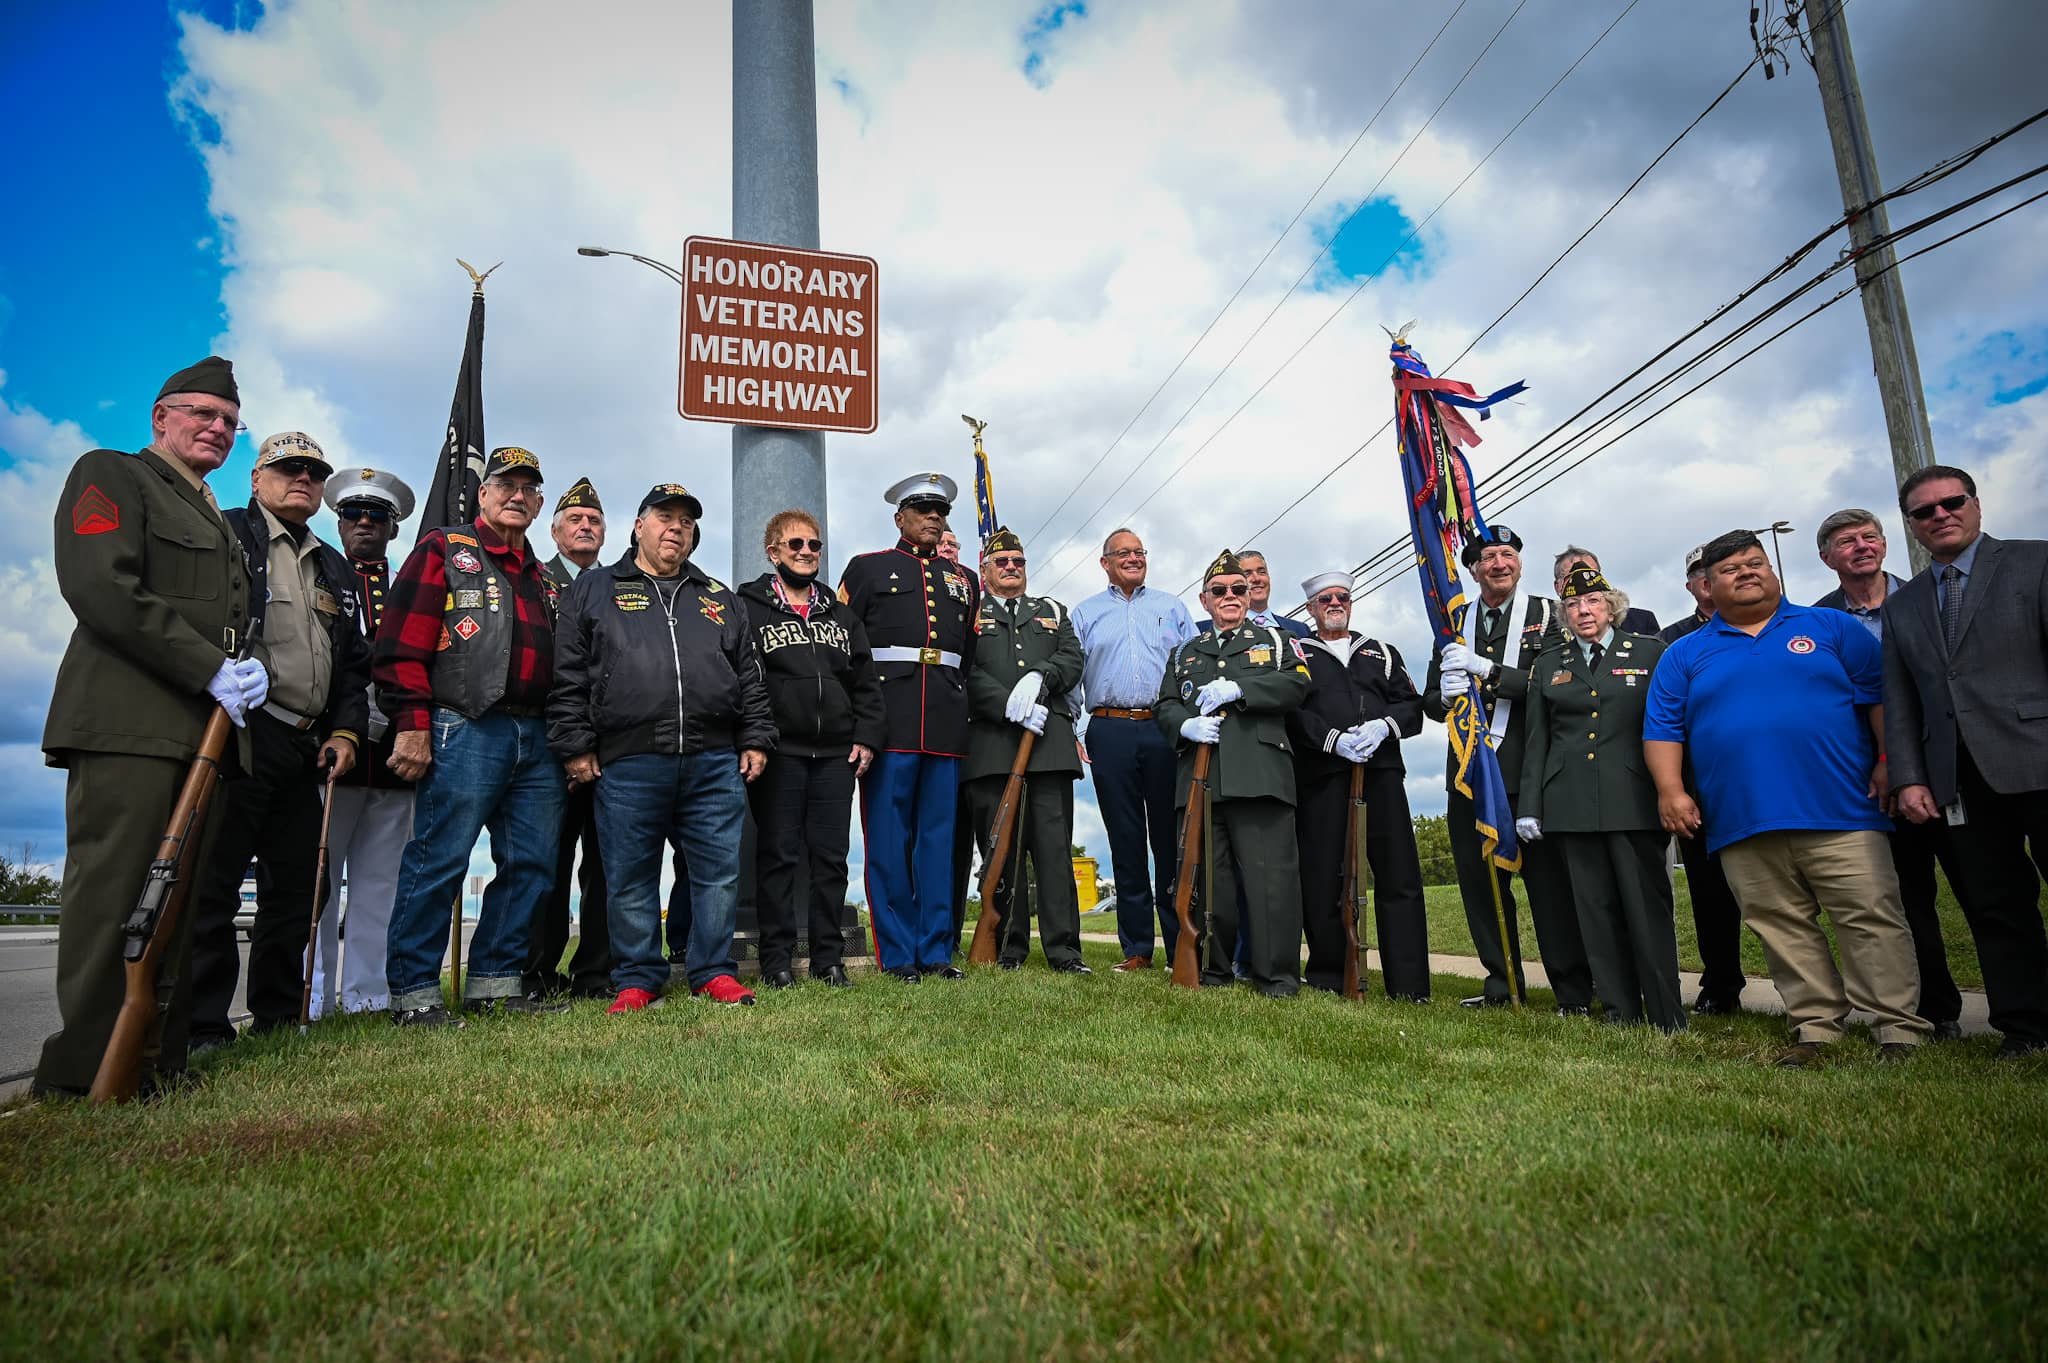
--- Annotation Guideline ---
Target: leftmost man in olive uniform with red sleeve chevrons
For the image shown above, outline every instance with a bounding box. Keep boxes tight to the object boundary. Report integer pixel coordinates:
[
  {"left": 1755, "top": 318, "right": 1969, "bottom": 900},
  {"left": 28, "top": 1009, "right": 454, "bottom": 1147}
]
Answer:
[{"left": 35, "top": 356, "right": 268, "bottom": 1093}]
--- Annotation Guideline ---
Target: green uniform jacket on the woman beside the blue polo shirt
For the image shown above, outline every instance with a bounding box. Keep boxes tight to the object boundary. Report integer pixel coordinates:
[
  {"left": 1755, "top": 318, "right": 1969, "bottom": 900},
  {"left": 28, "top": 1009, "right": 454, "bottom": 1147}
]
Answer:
[{"left": 1516, "top": 632, "right": 1665, "bottom": 833}]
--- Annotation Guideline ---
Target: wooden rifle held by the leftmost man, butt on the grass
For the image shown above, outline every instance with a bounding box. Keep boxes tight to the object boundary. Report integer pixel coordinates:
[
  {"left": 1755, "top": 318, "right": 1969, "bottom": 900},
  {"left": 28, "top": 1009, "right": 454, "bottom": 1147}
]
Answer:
[{"left": 92, "top": 706, "right": 233, "bottom": 1103}]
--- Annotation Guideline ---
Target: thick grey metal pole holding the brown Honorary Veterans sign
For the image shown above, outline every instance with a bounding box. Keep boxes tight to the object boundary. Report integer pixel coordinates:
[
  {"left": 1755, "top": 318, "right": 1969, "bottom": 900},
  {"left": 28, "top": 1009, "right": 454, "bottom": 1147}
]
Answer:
[{"left": 733, "top": 0, "right": 831, "bottom": 581}]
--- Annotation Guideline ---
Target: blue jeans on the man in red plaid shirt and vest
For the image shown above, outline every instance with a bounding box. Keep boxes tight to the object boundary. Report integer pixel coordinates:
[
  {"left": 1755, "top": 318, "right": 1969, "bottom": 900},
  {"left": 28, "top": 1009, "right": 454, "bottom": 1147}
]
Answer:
[{"left": 385, "top": 706, "right": 565, "bottom": 1009}]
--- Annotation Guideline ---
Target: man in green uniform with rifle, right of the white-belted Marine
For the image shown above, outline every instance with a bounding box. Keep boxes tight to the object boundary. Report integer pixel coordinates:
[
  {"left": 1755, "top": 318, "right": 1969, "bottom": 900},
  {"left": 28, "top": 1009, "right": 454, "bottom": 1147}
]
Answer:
[{"left": 961, "top": 528, "right": 1090, "bottom": 974}]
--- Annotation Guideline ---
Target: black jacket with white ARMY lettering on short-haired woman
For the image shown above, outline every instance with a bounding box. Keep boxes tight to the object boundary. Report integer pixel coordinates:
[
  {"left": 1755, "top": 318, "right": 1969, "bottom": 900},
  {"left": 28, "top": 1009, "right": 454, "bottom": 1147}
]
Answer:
[{"left": 739, "top": 573, "right": 885, "bottom": 757}]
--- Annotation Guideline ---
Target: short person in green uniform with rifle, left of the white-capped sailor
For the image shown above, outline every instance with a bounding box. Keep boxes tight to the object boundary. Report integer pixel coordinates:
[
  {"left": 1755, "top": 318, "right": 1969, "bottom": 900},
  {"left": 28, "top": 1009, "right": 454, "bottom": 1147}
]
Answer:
[{"left": 1153, "top": 551, "right": 1309, "bottom": 999}]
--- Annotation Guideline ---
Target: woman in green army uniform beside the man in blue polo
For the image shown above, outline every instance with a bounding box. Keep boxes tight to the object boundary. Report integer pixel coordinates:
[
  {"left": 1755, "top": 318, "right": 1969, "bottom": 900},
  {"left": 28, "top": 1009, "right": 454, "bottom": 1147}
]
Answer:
[{"left": 1516, "top": 567, "right": 1686, "bottom": 1031}]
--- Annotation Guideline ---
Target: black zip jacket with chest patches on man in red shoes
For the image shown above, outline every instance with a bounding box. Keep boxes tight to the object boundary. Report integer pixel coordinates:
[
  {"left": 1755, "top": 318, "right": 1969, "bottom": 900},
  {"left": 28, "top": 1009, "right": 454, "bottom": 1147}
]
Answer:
[{"left": 547, "top": 548, "right": 776, "bottom": 767}]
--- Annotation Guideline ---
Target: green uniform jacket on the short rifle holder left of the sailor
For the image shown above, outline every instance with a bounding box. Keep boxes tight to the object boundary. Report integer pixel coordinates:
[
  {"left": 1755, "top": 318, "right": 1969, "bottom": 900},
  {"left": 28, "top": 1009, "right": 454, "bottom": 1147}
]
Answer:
[{"left": 1153, "top": 624, "right": 1309, "bottom": 806}]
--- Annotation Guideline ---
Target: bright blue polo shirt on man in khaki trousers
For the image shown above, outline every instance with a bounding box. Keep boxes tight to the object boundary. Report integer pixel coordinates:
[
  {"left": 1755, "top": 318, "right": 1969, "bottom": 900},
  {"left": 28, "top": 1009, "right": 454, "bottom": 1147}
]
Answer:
[{"left": 1642, "top": 602, "right": 1892, "bottom": 851}]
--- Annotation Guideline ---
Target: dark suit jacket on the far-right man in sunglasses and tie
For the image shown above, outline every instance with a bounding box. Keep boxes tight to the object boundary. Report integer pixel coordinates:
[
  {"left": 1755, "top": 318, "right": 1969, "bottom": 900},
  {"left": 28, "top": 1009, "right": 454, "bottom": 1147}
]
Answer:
[{"left": 1884, "top": 534, "right": 2048, "bottom": 804}]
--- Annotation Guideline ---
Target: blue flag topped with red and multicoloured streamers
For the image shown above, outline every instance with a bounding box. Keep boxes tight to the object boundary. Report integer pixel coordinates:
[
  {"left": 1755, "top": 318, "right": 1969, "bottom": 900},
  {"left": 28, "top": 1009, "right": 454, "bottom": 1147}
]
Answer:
[{"left": 1389, "top": 327, "right": 1526, "bottom": 870}]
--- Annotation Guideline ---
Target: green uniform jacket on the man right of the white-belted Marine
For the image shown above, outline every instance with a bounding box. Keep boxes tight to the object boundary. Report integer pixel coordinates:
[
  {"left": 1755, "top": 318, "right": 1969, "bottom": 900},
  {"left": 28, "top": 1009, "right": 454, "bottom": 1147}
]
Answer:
[{"left": 961, "top": 593, "right": 1081, "bottom": 782}]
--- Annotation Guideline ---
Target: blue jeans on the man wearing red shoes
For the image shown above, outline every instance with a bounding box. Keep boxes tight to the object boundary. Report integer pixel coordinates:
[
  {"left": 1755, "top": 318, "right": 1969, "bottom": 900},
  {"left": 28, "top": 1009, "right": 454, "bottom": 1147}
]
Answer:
[{"left": 598, "top": 747, "right": 749, "bottom": 995}]
